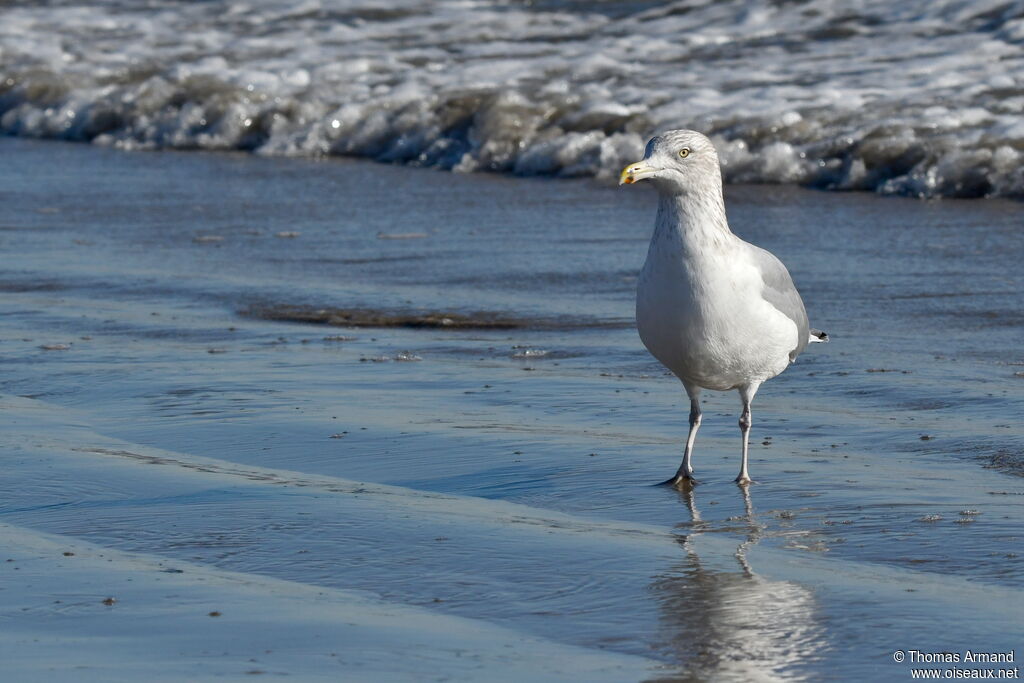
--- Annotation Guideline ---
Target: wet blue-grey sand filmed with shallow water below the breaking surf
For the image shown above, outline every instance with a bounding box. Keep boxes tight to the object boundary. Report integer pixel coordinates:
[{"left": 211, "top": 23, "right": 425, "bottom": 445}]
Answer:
[{"left": 0, "top": 139, "right": 1024, "bottom": 681}]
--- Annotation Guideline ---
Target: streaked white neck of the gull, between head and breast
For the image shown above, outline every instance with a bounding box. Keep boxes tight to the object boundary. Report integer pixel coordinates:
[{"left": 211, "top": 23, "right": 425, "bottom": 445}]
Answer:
[{"left": 654, "top": 190, "right": 732, "bottom": 251}]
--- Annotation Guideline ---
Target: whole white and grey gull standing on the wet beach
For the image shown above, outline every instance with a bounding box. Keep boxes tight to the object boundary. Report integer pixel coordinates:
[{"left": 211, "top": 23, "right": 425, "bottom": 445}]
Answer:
[{"left": 620, "top": 130, "right": 828, "bottom": 487}]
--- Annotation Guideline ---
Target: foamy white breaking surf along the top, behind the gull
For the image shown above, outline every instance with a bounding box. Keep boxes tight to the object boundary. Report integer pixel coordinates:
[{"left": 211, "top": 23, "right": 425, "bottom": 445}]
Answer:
[{"left": 6, "top": 0, "right": 1024, "bottom": 198}]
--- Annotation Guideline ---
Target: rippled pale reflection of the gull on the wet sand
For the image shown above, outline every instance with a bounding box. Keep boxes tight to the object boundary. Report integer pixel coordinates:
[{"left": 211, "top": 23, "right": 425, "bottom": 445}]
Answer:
[{"left": 651, "top": 486, "right": 825, "bottom": 682}]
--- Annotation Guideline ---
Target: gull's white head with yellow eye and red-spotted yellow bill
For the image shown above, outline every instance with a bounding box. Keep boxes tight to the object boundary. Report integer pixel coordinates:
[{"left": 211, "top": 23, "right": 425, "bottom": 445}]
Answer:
[{"left": 618, "top": 130, "right": 722, "bottom": 195}]
